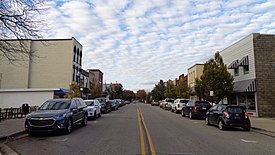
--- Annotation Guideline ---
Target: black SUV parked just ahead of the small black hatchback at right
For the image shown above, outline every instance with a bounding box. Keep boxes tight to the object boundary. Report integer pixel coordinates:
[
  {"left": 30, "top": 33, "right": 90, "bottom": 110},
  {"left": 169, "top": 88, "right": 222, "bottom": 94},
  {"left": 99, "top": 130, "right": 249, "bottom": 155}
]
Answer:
[{"left": 181, "top": 100, "right": 211, "bottom": 119}]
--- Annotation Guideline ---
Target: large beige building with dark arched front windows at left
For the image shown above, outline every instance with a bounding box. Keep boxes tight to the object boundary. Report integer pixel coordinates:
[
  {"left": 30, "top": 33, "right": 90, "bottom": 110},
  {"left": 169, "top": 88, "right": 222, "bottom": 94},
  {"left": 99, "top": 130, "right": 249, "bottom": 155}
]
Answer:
[{"left": 0, "top": 38, "right": 86, "bottom": 105}]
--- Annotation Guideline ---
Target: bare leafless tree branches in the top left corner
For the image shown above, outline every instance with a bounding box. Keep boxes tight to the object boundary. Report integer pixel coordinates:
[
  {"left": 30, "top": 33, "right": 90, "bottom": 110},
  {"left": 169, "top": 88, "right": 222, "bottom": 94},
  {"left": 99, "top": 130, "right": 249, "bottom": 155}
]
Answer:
[{"left": 0, "top": 0, "right": 45, "bottom": 63}]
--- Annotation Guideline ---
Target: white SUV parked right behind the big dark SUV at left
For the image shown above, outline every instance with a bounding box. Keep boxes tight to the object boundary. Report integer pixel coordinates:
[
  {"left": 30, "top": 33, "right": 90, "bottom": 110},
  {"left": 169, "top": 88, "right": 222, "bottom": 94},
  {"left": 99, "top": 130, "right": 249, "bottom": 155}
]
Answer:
[{"left": 84, "top": 100, "right": 101, "bottom": 119}]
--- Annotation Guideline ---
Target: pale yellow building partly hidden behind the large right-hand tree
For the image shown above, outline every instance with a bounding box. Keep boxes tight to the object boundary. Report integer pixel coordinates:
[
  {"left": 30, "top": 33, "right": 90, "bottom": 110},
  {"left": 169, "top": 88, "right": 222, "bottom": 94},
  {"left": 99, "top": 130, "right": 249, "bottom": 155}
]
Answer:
[{"left": 187, "top": 64, "right": 204, "bottom": 100}]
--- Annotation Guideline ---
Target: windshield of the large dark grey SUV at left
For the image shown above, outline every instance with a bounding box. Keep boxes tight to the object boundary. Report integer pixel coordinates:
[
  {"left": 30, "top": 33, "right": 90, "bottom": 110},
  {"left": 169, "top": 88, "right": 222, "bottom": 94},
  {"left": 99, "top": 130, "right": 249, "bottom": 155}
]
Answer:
[{"left": 39, "top": 100, "right": 71, "bottom": 110}]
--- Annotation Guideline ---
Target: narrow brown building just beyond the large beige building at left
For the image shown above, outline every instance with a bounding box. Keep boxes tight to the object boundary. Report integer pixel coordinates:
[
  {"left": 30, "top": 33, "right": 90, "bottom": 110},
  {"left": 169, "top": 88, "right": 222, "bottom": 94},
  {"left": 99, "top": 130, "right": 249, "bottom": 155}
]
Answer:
[{"left": 88, "top": 69, "right": 103, "bottom": 98}]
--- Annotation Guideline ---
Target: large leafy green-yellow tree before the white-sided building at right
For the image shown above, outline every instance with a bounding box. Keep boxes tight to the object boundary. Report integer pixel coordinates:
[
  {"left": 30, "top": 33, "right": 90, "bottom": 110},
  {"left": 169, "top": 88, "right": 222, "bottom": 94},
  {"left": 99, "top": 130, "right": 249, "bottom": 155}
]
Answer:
[{"left": 195, "top": 52, "right": 234, "bottom": 103}]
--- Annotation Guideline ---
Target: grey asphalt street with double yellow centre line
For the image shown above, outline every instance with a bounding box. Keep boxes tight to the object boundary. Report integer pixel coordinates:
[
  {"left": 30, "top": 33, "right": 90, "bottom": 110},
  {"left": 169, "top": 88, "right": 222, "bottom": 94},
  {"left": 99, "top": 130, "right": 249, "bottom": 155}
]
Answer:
[{"left": 3, "top": 103, "right": 275, "bottom": 155}]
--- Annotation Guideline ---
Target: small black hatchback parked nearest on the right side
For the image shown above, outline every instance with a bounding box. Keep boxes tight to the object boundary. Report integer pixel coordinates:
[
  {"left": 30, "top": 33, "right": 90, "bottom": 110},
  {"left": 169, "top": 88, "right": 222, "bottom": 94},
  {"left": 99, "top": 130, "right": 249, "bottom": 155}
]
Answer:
[{"left": 205, "top": 104, "right": 251, "bottom": 131}]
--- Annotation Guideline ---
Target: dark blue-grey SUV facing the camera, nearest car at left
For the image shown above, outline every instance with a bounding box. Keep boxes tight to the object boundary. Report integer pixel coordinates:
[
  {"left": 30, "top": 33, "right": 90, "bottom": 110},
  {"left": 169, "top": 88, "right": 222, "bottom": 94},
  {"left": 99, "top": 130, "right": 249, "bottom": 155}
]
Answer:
[{"left": 25, "top": 98, "right": 88, "bottom": 135}]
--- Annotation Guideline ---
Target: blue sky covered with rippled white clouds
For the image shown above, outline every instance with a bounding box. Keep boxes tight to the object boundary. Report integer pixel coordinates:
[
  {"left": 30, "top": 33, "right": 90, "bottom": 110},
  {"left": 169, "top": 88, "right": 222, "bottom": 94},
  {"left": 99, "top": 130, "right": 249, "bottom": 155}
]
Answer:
[{"left": 43, "top": 0, "right": 275, "bottom": 91}]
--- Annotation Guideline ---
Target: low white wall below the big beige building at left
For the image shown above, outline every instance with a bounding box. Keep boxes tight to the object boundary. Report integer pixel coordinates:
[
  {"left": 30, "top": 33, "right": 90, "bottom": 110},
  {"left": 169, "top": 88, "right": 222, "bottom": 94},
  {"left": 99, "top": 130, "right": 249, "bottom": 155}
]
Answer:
[{"left": 0, "top": 91, "right": 54, "bottom": 108}]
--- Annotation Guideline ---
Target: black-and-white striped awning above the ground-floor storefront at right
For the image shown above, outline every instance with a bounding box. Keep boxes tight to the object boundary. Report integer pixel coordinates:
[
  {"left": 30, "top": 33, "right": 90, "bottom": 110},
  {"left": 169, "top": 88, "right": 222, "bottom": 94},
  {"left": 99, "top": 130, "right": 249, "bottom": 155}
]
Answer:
[{"left": 233, "top": 79, "right": 256, "bottom": 92}]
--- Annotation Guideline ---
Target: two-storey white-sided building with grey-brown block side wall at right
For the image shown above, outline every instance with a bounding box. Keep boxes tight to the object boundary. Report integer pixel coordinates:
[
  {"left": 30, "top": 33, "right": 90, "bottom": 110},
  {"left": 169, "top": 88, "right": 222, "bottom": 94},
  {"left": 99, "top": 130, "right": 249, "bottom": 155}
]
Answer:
[{"left": 220, "top": 33, "right": 275, "bottom": 117}]
